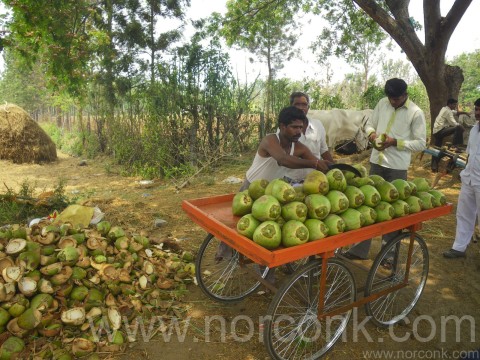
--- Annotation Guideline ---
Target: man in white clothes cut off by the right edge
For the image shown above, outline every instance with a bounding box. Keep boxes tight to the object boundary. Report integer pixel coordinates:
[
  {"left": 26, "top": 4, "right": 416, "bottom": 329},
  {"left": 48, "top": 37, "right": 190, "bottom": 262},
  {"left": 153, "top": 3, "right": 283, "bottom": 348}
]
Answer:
[{"left": 443, "top": 98, "right": 480, "bottom": 259}]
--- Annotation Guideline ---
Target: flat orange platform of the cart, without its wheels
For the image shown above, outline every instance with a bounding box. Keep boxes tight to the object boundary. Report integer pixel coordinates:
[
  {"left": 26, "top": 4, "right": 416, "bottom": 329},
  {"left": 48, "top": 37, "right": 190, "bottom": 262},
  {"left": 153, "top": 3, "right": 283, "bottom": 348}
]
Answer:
[{"left": 182, "top": 194, "right": 453, "bottom": 268}]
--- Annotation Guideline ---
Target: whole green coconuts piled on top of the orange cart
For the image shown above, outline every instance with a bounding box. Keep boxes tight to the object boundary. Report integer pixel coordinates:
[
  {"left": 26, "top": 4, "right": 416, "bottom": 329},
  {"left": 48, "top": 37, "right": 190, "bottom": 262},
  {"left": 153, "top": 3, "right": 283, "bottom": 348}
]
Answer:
[{"left": 232, "top": 164, "right": 446, "bottom": 250}]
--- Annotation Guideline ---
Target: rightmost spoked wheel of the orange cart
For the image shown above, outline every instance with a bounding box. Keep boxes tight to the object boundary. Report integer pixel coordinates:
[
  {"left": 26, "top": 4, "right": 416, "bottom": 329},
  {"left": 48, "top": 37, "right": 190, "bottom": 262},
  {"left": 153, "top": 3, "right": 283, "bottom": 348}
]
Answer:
[{"left": 365, "top": 233, "right": 428, "bottom": 327}]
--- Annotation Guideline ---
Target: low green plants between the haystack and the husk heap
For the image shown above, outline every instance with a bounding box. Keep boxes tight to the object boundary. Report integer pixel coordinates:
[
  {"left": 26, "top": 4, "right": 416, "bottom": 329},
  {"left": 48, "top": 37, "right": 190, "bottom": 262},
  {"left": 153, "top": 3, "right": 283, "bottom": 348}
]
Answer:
[{"left": 0, "top": 180, "right": 70, "bottom": 226}]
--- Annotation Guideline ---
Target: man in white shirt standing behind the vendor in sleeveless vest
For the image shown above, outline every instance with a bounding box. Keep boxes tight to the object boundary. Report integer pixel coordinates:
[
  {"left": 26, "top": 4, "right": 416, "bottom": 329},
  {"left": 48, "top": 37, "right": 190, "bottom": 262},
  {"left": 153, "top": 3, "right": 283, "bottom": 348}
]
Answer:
[{"left": 285, "top": 91, "right": 334, "bottom": 182}]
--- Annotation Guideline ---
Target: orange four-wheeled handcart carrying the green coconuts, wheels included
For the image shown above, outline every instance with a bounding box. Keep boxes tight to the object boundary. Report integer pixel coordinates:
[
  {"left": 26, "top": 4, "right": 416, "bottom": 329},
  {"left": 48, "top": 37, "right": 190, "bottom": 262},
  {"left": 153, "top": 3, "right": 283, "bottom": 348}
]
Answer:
[{"left": 182, "top": 194, "right": 452, "bottom": 359}]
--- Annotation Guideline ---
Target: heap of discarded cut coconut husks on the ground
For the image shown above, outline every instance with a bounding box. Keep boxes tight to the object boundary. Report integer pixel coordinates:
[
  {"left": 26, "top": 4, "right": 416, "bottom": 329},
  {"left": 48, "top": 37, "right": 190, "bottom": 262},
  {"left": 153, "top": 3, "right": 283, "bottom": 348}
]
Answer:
[{"left": 0, "top": 220, "right": 195, "bottom": 359}]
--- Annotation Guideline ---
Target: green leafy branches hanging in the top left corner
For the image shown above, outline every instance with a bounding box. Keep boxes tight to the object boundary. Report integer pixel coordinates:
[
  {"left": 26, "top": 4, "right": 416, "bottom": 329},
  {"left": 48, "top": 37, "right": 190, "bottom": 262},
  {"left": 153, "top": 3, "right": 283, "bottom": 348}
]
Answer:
[{"left": 3, "top": 0, "right": 95, "bottom": 94}]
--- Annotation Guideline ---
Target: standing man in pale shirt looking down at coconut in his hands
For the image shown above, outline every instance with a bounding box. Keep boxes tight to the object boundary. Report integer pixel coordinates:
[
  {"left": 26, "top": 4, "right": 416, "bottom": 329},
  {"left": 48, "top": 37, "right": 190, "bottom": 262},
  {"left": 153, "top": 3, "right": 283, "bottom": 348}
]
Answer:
[{"left": 344, "top": 78, "right": 427, "bottom": 267}]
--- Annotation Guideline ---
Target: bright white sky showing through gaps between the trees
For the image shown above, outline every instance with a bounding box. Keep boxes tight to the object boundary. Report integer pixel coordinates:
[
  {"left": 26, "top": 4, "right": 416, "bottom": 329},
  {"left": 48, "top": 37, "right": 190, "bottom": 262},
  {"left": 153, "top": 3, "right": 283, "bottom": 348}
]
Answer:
[{"left": 183, "top": 0, "right": 480, "bottom": 81}]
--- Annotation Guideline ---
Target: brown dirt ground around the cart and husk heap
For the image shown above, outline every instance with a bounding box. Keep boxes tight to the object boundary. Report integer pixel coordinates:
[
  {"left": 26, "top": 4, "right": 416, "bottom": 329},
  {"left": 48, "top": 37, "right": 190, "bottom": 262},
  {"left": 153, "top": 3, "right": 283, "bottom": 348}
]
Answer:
[{"left": 0, "top": 153, "right": 480, "bottom": 360}]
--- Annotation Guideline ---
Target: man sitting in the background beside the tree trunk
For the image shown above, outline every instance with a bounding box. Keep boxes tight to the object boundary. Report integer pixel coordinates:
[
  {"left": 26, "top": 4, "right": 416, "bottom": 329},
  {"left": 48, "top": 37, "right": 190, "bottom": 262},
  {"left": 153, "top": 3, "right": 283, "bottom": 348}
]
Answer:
[{"left": 432, "top": 99, "right": 467, "bottom": 172}]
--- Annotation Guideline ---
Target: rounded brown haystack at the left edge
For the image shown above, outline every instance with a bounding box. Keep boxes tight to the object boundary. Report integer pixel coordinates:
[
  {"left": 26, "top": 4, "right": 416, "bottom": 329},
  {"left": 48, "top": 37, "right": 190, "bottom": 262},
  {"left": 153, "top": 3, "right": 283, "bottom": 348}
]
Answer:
[{"left": 0, "top": 104, "right": 57, "bottom": 164}]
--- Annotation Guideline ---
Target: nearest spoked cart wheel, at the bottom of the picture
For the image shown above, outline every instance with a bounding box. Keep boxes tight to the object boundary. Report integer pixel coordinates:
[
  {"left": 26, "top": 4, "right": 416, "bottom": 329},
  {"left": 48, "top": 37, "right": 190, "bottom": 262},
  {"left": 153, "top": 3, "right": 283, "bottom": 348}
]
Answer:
[{"left": 263, "top": 259, "right": 356, "bottom": 359}]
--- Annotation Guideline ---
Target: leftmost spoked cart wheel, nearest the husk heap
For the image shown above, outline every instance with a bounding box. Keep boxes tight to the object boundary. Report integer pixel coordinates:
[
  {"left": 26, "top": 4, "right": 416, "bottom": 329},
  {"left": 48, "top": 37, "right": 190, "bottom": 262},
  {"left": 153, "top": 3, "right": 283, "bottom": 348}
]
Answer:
[{"left": 195, "top": 234, "right": 269, "bottom": 302}]
